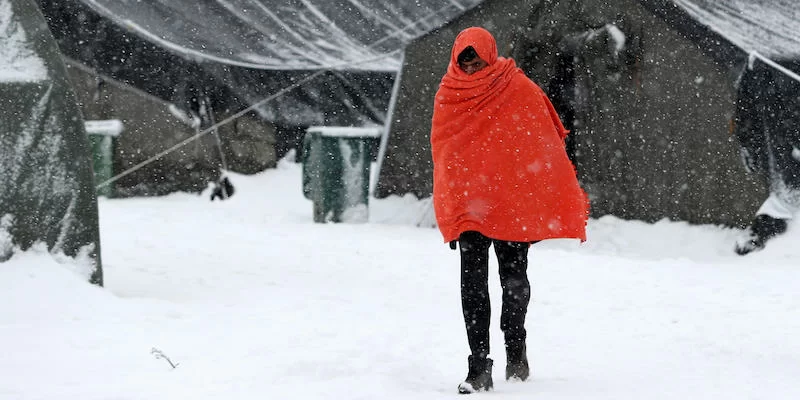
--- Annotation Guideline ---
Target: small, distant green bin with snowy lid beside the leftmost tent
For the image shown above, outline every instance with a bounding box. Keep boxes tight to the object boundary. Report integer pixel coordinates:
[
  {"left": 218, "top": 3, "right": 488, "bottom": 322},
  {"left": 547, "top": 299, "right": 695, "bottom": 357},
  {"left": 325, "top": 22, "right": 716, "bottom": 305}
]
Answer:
[{"left": 85, "top": 119, "right": 122, "bottom": 197}]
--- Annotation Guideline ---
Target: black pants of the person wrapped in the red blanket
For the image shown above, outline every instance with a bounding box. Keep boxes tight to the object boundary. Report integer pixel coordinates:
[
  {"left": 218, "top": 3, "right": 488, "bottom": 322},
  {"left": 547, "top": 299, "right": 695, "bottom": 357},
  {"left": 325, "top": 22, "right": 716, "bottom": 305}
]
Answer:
[{"left": 458, "top": 231, "right": 531, "bottom": 357}]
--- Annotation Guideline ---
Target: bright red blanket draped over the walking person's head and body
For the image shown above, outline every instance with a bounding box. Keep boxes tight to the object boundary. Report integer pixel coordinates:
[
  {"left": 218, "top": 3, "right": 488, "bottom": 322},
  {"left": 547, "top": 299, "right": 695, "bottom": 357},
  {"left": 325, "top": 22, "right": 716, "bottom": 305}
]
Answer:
[{"left": 431, "top": 28, "right": 588, "bottom": 242}]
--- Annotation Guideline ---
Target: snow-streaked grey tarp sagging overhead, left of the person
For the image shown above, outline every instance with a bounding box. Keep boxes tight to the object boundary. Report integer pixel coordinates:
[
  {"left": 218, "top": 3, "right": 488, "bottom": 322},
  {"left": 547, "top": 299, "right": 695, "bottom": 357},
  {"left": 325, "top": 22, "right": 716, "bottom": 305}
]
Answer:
[{"left": 81, "top": 0, "right": 482, "bottom": 70}]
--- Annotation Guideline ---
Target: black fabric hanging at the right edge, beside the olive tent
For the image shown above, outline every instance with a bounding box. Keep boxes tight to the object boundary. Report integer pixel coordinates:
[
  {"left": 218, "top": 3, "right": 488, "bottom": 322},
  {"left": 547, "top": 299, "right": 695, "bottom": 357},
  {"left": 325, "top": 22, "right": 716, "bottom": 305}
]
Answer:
[{"left": 734, "top": 57, "right": 800, "bottom": 209}]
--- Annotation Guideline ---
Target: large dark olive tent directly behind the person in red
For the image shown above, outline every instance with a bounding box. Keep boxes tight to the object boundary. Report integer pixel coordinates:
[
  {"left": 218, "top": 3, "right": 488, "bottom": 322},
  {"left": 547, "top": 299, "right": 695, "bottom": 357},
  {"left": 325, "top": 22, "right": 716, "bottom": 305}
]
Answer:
[{"left": 376, "top": 0, "right": 800, "bottom": 226}]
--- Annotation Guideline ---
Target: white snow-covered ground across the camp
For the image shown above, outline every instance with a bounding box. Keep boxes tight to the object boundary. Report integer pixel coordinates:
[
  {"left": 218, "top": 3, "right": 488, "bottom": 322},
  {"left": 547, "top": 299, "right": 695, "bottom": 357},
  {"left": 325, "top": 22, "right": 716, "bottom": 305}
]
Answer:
[{"left": 0, "top": 157, "right": 800, "bottom": 400}]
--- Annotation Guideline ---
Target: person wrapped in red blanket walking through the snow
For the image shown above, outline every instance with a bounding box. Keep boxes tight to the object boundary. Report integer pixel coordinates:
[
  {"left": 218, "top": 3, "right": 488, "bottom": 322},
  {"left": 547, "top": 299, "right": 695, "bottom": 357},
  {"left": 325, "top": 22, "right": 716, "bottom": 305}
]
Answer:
[{"left": 431, "top": 27, "right": 588, "bottom": 393}]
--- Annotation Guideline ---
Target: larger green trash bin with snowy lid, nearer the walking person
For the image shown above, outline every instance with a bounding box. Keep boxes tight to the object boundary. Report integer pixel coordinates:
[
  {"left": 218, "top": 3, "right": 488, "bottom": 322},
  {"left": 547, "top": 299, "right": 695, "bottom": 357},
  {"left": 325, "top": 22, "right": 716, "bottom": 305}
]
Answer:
[{"left": 302, "top": 126, "right": 382, "bottom": 223}]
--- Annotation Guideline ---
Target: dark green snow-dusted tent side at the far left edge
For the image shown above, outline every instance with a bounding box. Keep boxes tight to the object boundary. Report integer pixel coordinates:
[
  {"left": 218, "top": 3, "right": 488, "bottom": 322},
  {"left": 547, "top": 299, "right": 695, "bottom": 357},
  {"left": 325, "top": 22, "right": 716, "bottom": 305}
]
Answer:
[{"left": 0, "top": 0, "right": 102, "bottom": 284}]
